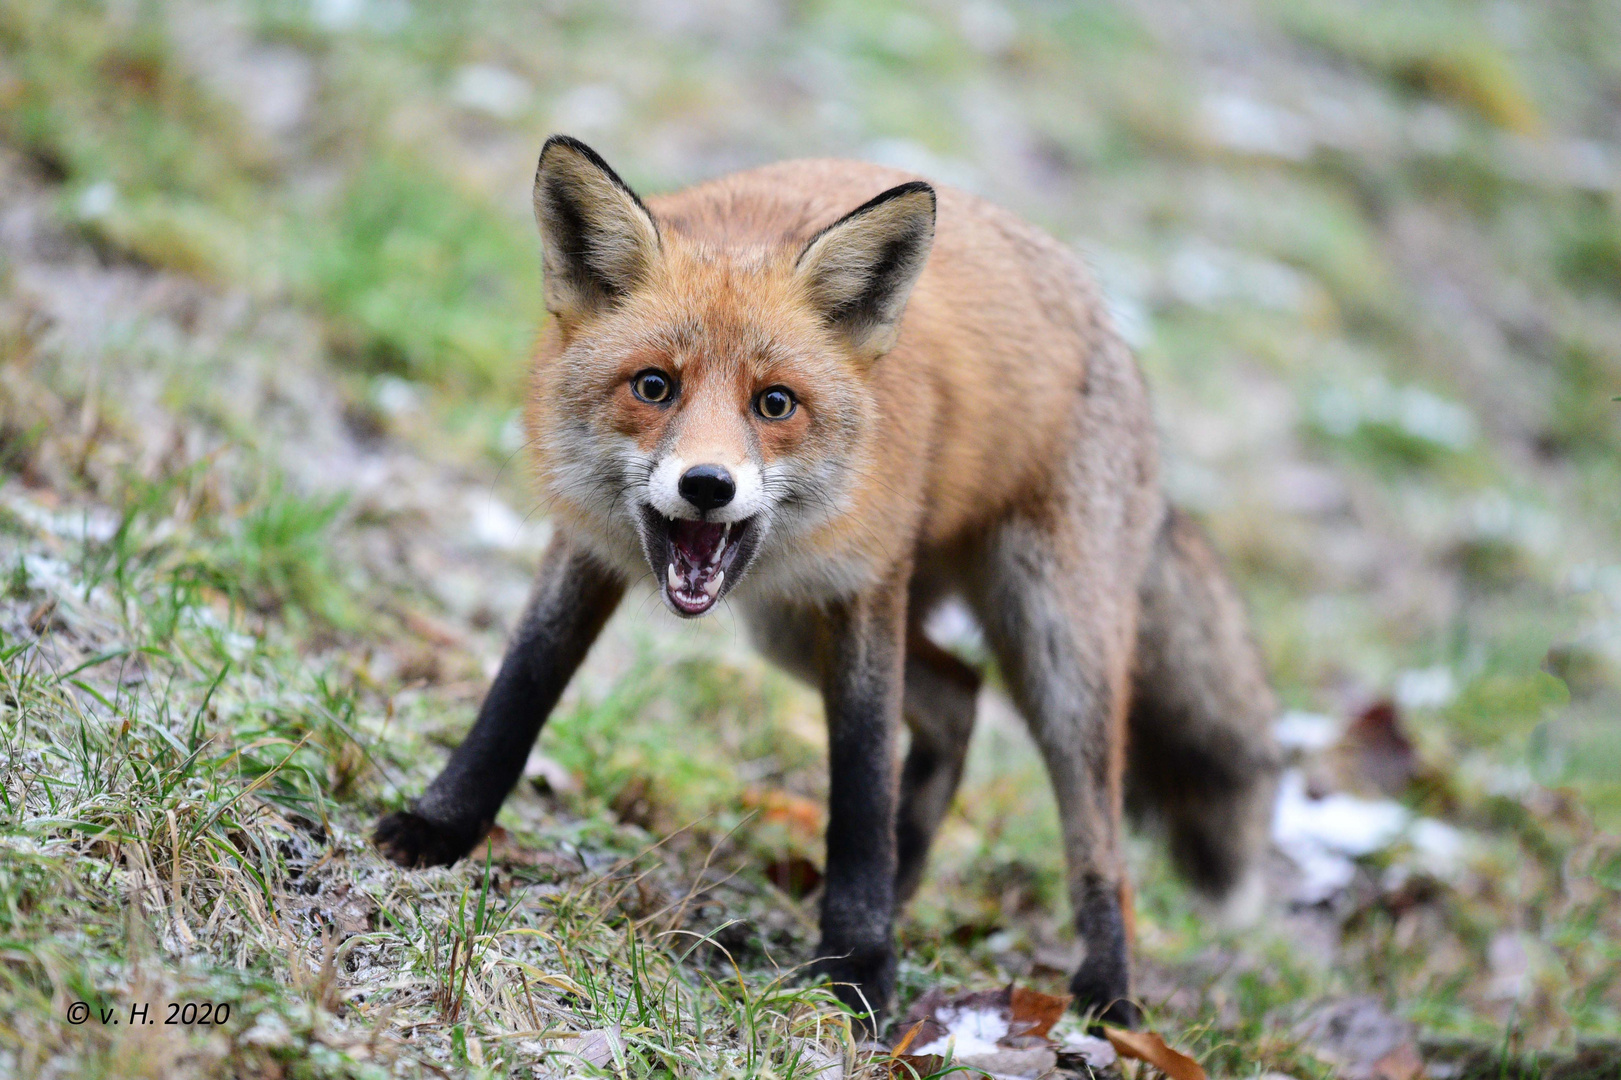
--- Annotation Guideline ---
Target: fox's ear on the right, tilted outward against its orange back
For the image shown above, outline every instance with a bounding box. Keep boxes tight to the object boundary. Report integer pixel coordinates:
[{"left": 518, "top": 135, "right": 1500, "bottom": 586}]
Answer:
[{"left": 794, "top": 180, "right": 934, "bottom": 357}]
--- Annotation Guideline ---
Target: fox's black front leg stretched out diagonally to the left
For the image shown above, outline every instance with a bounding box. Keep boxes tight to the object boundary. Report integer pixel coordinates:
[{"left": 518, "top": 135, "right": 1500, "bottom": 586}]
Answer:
[{"left": 373, "top": 532, "right": 624, "bottom": 866}]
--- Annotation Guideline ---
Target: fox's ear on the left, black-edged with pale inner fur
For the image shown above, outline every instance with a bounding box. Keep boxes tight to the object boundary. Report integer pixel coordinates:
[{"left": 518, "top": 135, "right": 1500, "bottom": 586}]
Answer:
[{"left": 535, "top": 135, "right": 658, "bottom": 316}]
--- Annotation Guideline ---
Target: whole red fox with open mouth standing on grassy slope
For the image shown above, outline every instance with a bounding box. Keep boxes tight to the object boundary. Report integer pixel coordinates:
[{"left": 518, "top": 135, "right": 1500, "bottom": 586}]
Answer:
[{"left": 376, "top": 136, "right": 1279, "bottom": 1025}]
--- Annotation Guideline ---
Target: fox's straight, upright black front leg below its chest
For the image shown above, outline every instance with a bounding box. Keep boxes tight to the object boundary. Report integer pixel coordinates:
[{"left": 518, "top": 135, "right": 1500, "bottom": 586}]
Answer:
[{"left": 812, "top": 567, "right": 906, "bottom": 1028}]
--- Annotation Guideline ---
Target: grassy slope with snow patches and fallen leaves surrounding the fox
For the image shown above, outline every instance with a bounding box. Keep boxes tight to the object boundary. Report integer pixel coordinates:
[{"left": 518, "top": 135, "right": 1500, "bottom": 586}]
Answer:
[{"left": 0, "top": 0, "right": 1621, "bottom": 1080}]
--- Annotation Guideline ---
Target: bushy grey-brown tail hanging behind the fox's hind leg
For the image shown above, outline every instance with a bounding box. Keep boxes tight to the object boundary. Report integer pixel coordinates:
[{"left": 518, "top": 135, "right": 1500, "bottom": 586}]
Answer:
[{"left": 1127, "top": 511, "right": 1279, "bottom": 900}]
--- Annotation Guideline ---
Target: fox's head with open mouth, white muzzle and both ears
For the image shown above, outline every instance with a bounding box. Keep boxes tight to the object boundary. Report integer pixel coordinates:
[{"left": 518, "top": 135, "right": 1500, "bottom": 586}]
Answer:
[{"left": 527, "top": 136, "right": 935, "bottom": 618}]
